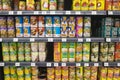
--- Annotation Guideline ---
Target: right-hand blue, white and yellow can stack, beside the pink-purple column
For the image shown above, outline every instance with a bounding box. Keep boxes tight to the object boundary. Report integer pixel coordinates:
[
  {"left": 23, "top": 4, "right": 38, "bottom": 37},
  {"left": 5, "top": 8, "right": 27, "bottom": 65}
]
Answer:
[{"left": 68, "top": 16, "right": 75, "bottom": 37}]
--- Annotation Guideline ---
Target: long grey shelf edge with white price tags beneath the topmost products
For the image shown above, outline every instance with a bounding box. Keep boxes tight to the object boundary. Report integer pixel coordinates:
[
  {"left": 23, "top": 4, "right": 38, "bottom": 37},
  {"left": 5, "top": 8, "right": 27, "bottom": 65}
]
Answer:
[{"left": 0, "top": 11, "right": 107, "bottom": 15}]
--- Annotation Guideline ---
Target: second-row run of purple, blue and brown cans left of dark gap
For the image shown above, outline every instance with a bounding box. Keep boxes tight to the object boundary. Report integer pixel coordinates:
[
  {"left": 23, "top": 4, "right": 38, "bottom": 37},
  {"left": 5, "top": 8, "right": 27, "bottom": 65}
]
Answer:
[{"left": 0, "top": 16, "right": 91, "bottom": 37}]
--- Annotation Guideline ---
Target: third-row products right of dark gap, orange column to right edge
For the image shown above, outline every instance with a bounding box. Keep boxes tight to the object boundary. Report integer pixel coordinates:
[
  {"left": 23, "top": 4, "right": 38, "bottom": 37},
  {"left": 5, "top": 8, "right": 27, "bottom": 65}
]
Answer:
[{"left": 54, "top": 42, "right": 120, "bottom": 62}]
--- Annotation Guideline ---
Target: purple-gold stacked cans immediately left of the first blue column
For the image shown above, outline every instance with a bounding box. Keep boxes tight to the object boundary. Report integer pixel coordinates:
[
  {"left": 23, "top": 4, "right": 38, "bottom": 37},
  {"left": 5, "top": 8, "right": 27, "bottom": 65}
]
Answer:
[{"left": 7, "top": 17, "right": 15, "bottom": 37}]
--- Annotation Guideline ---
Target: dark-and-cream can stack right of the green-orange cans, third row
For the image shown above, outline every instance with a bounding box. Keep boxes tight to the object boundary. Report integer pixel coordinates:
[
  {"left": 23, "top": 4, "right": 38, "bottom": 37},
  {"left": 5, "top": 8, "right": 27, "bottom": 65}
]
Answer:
[{"left": 91, "top": 43, "right": 99, "bottom": 62}]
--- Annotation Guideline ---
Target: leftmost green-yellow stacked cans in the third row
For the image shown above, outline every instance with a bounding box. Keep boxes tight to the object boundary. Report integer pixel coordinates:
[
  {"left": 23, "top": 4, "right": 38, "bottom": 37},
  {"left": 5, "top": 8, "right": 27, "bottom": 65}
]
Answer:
[{"left": 2, "top": 43, "right": 10, "bottom": 62}]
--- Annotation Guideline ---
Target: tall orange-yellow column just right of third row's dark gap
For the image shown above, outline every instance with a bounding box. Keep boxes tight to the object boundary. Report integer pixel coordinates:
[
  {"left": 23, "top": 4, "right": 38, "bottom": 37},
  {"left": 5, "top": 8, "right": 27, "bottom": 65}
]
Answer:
[{"left": 54, "top": 43, "right": 61, "bottom": 62}]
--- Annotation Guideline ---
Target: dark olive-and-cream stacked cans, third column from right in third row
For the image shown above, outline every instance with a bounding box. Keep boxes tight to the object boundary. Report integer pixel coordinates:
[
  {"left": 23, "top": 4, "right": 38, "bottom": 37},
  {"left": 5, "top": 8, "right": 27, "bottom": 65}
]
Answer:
[{"left": 100, "top": 43, "right": 108, "bottom": 62}]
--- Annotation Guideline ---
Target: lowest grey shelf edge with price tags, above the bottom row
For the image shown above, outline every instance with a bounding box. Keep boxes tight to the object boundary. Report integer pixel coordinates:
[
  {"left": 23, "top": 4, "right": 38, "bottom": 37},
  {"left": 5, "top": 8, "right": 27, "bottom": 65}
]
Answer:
[{"left": 0, "top": 62, "right": 120, "bottom": 67}]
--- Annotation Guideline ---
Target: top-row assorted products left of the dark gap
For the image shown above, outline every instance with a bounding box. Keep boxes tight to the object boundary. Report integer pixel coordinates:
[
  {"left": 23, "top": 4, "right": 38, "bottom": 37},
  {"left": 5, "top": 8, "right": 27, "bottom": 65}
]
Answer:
[{"left": 0, "top": 0, "right": 64, "bottom": 11}]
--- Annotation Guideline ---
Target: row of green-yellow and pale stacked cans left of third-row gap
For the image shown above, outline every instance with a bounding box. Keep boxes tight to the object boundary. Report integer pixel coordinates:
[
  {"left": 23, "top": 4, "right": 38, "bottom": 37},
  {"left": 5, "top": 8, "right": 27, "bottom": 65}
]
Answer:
[{"left": 2, "top": 43, "right": 46, "bottom": 61}]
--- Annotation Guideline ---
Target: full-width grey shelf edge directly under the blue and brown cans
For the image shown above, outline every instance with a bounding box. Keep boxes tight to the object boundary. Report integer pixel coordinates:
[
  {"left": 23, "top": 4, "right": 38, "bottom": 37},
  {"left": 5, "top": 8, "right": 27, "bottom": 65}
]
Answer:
[{"left": 0, "top": 38, "right": 120, "bottom": 42}]
